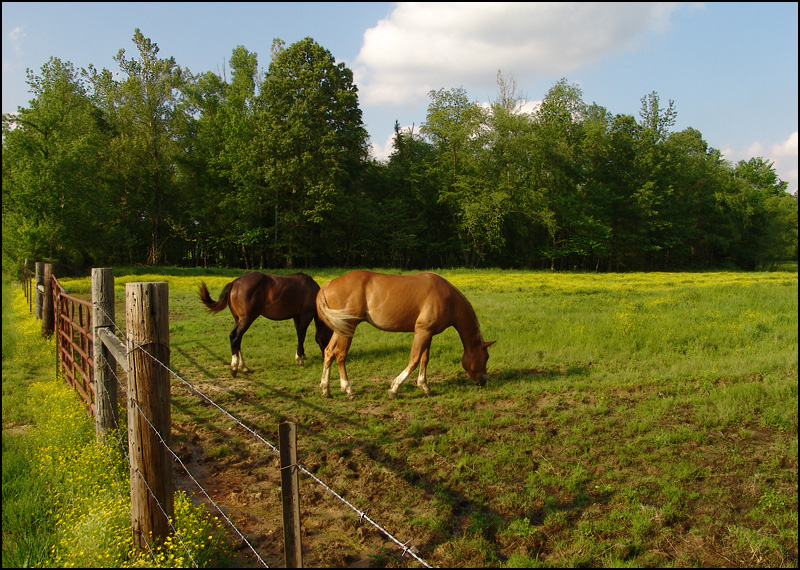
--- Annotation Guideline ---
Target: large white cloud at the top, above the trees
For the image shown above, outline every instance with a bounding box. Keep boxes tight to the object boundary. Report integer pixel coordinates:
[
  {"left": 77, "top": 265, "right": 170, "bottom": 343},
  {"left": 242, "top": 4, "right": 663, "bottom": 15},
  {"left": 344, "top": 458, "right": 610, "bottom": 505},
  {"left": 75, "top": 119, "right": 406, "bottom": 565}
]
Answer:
[{"left": 352, "top": 2, "right": 677, "bottom": 105}]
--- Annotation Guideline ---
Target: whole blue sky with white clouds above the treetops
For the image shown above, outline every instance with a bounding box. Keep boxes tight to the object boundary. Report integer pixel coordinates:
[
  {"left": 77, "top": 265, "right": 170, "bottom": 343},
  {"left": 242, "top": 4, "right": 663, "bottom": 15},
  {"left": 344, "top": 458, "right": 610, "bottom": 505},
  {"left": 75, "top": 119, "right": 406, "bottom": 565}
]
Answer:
[{"left": 2, "top": 2, "right": 798, "bottom": 192}]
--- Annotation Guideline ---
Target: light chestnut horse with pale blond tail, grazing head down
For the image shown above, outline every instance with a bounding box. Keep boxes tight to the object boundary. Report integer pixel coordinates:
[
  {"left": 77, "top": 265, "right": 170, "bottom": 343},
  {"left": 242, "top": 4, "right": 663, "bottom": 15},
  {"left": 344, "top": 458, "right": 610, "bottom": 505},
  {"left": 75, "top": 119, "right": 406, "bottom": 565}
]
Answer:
[{"left": 317, "top": 271, "right": 494, "bottom": 399}]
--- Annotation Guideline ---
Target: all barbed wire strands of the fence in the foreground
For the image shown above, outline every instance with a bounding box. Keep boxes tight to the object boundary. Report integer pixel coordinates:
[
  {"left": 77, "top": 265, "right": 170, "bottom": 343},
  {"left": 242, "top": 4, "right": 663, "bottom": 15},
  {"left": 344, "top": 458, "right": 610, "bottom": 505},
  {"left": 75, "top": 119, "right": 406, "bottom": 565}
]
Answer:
[{"left": 21, "top": 268, "right": 432, "bottom": 568}]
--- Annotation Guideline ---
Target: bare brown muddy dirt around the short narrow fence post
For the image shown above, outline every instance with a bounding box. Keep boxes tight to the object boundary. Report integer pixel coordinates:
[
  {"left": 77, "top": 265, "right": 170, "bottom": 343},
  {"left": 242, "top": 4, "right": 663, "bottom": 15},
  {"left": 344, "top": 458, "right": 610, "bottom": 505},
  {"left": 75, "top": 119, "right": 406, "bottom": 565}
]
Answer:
[{"left": 174, "top": 414, "right": 422, "bottom": 568}]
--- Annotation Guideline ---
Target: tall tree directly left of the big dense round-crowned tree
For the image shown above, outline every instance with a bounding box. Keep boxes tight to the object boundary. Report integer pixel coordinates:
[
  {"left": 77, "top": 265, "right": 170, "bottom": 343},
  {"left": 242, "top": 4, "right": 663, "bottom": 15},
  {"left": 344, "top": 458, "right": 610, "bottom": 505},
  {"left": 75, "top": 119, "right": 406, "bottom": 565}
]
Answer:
[{"left": 176, "top": 46, "right": 271, "bottom": 268}]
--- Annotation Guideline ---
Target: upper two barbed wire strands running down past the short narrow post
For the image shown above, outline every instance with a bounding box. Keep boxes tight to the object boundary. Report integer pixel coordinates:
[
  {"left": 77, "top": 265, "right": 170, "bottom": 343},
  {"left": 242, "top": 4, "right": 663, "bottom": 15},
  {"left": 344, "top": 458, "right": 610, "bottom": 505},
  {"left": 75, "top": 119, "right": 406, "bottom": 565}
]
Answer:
[{"left": 90, "top": 304, "right": 432, "bottom": 568}]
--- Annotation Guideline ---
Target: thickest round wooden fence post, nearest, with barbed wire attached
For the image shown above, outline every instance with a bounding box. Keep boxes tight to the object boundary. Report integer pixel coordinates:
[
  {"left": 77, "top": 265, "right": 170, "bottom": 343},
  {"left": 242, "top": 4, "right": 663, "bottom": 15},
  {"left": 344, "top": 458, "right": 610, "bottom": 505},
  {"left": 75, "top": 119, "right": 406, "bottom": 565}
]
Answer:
[{"left": 125, "top": 282, "right": 175, "bottom": 548}]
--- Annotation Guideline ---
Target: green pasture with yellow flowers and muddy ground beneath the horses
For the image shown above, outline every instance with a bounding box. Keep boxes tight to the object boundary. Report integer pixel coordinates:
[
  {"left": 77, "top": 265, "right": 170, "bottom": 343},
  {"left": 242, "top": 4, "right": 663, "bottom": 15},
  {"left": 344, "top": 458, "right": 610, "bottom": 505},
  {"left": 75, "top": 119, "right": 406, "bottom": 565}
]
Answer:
[{"left": 4, "top": 268, "right": 798, "bottom": 567}]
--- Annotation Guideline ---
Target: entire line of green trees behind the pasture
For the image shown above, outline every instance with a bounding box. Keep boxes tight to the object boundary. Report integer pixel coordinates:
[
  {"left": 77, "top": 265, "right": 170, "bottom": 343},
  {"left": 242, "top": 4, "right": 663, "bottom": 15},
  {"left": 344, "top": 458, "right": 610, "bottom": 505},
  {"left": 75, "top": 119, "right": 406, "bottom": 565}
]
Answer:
[{"left": 3, "top": 29, "right": 798, "bottom": 271}]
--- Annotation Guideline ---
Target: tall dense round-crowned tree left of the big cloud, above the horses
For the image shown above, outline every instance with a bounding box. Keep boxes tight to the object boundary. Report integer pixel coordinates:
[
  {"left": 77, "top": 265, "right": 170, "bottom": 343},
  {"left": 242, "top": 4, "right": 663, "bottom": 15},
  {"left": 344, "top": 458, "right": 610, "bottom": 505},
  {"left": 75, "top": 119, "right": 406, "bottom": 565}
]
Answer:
[{"left": 257, "top": 38, "right": 367, "bottom": 267}]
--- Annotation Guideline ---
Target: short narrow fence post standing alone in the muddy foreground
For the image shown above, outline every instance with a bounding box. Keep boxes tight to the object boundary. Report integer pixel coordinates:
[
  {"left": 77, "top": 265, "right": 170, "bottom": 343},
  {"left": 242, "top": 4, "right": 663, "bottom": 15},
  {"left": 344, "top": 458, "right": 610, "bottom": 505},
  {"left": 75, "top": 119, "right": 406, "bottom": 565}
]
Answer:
[{"left": 278, "top": 422, "right": 303, "bottom": 568}]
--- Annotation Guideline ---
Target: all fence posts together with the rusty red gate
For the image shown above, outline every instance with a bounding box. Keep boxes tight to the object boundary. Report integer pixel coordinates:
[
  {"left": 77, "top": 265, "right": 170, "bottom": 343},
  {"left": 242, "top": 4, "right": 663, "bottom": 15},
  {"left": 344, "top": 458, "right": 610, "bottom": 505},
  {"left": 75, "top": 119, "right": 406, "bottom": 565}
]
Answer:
[{"left": 21, "top": 263, "right": 302, "bottom": 568}]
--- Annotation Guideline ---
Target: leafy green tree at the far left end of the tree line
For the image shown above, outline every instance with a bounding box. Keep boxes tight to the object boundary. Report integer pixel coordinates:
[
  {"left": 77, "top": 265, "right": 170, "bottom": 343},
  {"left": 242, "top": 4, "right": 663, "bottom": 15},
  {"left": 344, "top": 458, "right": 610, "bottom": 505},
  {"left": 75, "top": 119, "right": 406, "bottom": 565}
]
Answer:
[{"left": 3, "top": 58, "right": 113, "bottom": 271}]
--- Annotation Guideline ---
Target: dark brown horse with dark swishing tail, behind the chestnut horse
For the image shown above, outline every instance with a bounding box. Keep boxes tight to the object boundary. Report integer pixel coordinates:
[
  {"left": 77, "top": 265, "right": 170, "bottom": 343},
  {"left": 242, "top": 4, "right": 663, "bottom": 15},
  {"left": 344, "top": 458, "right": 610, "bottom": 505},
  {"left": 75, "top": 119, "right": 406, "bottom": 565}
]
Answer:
[{"left": 199, "top": 271, "right": 333, "bottom": 378}]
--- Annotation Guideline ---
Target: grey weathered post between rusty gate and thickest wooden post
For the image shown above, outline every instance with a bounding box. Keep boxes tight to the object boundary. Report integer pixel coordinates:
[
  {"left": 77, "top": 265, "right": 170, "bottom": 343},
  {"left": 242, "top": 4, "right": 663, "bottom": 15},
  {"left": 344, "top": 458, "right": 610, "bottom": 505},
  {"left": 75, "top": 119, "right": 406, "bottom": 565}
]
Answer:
[{"left": 92, "top": 267, "right": 119, "bottom": 437}]
